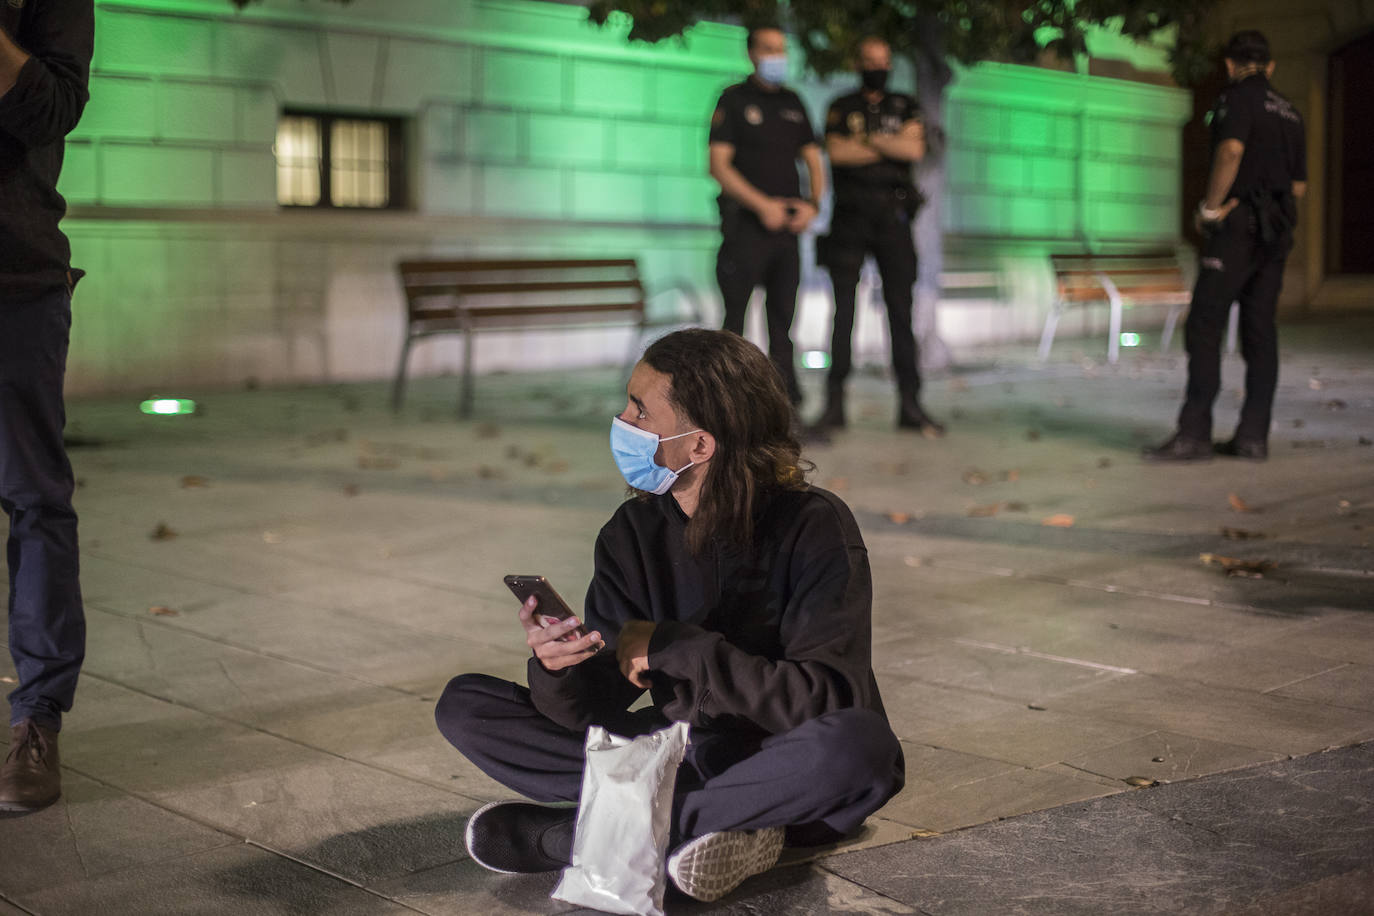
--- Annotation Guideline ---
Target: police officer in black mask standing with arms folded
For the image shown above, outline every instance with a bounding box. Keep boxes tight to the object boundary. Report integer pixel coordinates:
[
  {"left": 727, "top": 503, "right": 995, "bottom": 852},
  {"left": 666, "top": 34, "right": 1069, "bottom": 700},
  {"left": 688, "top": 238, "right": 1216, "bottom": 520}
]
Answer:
[{"left": 812, "top": 37, "right": 944, "bottom": 435}]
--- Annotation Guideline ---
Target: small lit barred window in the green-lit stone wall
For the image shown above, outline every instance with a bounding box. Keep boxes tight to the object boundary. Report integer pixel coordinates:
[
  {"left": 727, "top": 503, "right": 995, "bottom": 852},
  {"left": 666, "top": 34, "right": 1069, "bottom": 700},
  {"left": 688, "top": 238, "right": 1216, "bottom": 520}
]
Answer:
[{"left": 273, "top": 111, "right": 405, "bottom": 210}]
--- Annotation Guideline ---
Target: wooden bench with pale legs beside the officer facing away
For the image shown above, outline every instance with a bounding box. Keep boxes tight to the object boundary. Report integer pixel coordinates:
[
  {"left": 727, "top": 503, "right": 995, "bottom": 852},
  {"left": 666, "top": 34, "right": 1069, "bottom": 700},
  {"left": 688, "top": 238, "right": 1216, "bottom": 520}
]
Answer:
[{"left": 1040, "top": 251, "right": 1193, "bottom": 363}]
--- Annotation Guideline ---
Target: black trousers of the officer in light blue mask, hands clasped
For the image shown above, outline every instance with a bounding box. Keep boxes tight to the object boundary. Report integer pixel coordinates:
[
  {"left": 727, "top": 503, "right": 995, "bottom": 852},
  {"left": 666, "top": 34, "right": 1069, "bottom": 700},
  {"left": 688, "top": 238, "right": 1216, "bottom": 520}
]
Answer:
[{"left": 716, "top": 214, "right": 801, "bottom": 404}]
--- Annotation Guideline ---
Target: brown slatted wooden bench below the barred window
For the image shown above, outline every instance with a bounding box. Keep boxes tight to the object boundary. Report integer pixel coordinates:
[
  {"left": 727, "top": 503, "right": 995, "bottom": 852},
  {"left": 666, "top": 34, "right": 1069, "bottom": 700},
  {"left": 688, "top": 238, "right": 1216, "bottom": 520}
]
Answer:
[{"left": 392, "top": 258, "right": 646, "bottom": 417}]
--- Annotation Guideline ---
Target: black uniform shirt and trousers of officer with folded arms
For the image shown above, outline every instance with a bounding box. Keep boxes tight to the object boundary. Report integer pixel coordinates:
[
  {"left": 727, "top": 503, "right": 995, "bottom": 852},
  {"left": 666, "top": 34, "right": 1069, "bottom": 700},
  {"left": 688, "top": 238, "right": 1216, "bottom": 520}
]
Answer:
[{"left": 820, "top": 91, "right": 923, "bottom": 426}]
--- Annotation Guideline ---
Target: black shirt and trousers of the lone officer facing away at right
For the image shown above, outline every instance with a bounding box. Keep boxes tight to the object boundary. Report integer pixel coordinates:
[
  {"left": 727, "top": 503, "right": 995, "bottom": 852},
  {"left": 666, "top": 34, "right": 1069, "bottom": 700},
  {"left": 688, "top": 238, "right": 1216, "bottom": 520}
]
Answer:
[{"left": 1179, "top": 73, "right": 1307, "bottom": 450}]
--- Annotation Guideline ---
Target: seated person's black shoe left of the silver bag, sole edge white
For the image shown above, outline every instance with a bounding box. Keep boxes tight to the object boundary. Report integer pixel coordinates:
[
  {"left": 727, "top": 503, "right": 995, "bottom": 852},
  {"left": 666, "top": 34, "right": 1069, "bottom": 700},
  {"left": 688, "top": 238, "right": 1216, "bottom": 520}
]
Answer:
[{"left": 466, "top": 802, "right": 577, "bottom": 875}]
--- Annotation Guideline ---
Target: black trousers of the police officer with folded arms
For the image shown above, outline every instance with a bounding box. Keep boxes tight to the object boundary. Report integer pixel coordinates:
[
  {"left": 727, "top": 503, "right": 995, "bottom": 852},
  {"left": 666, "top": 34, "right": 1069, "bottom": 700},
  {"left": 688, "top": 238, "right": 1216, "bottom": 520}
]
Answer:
[{"left": 826, "top": 201, "right": 921, "bottom": 398}]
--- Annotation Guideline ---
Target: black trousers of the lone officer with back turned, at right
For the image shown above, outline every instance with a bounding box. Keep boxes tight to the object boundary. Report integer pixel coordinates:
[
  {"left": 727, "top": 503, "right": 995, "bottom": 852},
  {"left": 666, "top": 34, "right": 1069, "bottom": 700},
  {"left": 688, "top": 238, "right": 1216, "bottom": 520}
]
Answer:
[{"left": 1179, "top": 212, "right": 1292, "bottom": 442}]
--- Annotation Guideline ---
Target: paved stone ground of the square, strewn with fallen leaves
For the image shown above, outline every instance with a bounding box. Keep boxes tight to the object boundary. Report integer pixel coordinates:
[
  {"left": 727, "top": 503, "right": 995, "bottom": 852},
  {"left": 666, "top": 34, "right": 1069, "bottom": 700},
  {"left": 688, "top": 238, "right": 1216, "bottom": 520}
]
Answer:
[{"left": 8, "top": 319, "right": 1374, "bottom": 916}]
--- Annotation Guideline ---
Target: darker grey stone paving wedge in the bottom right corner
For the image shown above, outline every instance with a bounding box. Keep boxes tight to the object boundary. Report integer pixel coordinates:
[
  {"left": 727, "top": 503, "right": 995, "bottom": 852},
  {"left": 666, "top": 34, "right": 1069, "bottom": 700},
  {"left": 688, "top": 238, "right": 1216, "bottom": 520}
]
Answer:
[{"left": 823, "top": 746, "right": 1374, "bottom": 916}]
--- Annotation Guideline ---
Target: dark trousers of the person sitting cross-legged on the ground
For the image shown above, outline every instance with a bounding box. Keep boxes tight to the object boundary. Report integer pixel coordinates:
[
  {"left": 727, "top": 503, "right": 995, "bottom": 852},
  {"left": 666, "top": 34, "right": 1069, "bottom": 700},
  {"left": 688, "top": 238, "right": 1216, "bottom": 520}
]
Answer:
[{"left": 434, "top": 674, "right": 905, "bottom": 845}]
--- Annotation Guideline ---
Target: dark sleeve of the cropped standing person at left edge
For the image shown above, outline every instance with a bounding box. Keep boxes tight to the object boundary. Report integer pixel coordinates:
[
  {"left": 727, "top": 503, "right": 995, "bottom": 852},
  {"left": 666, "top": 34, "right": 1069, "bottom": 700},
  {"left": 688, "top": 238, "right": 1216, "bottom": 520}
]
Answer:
[{"left": 0, "top": 0, "right": 95, "bottom": 147}]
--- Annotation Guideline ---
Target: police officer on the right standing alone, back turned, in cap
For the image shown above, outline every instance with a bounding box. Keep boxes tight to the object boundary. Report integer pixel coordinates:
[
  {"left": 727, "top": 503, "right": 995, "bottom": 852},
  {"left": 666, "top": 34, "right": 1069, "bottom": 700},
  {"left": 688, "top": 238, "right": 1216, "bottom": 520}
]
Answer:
[{"left": 1145, "top": 30, "right": 1307, "bottom": 461}]
